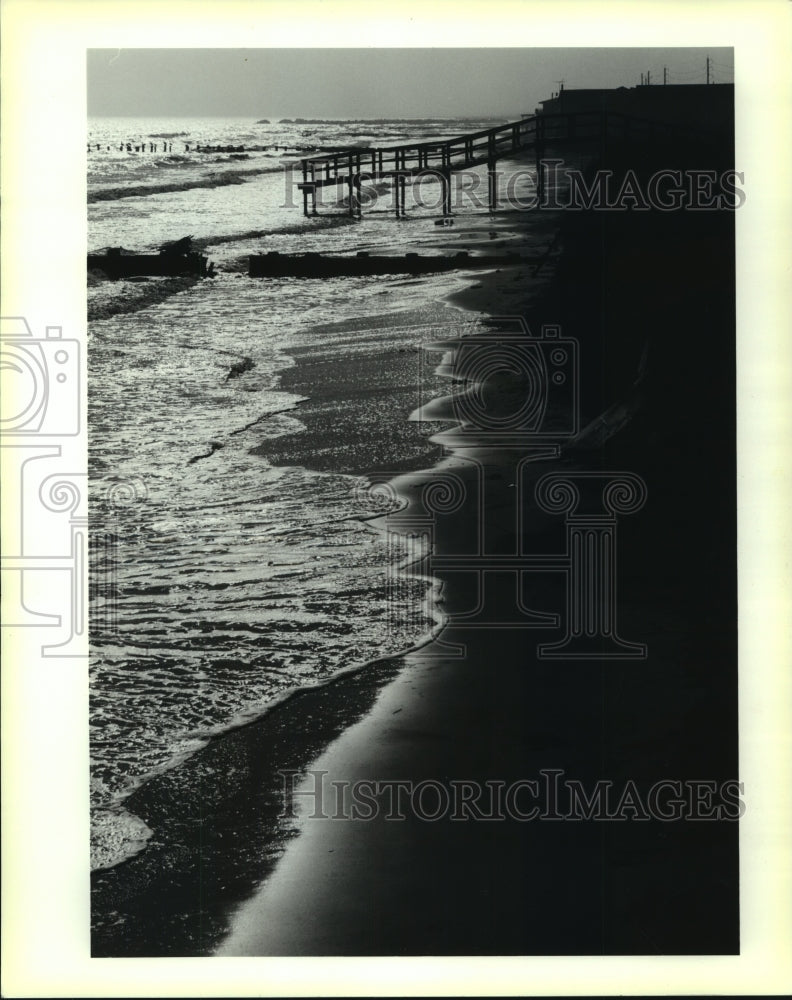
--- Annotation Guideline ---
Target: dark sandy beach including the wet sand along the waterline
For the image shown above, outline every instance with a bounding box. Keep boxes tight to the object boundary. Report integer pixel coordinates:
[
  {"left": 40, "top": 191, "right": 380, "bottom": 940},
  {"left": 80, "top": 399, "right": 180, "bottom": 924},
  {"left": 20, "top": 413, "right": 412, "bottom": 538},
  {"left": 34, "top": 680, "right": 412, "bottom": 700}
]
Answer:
[{"left": 93, "top": 131, "right": 738, "bottom": 956}]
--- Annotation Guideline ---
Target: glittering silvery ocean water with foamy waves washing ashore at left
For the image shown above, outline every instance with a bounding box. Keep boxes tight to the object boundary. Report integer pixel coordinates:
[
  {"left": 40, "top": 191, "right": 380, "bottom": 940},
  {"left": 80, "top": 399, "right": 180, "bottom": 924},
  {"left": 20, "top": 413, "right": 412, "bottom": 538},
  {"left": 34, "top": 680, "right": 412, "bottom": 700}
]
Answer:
[{"left": 87, "top": 113, "right": 540, "bottom": 867}]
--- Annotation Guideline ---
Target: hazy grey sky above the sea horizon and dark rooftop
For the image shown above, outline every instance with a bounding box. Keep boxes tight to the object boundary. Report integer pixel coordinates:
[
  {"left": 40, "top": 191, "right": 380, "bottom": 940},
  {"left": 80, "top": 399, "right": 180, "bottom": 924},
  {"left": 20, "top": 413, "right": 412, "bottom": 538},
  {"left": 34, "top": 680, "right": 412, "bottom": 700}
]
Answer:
[{"left": 87, "top": 48, "right": 733, "bottom": 120}]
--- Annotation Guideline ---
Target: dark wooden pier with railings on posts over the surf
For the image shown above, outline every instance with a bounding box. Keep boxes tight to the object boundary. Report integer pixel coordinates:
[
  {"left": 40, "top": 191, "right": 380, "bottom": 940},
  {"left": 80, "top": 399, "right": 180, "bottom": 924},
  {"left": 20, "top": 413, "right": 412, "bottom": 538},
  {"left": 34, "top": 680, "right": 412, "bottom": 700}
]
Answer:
[{"left": 297, "top": 112, "right": 704, "bottom": 218}]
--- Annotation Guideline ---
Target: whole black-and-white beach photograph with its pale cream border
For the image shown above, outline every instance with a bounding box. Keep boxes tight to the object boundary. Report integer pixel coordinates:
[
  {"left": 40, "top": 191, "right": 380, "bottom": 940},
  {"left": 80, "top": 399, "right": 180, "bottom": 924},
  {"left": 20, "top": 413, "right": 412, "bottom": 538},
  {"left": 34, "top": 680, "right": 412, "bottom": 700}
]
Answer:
[{"left": 2, "top": 3, "right": 790, "bottom": 996}]
